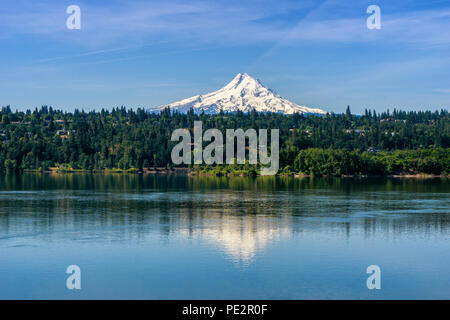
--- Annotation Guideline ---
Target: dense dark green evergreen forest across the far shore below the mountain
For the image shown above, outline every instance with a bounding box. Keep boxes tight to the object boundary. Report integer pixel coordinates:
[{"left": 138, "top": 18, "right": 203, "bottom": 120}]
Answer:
[{"left": 0, "top": 106, "right": 450, "bottom": 175}]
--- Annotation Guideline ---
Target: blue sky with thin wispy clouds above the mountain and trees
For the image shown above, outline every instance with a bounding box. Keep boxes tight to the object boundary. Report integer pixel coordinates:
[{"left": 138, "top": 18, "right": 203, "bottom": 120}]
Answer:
[{"left": 0, "top": 0, "right": 450, "bottom": 113}]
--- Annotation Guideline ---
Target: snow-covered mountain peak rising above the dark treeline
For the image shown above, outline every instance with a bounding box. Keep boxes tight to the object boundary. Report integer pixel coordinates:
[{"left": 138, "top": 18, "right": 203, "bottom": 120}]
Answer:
[{"left": 150, "top": 73, "right": 326, "bottom": 114}]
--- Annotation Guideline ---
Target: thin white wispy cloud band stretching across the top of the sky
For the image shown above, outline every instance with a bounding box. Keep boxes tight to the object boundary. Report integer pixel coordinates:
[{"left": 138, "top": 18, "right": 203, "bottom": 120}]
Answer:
[{"left": 0, "top": 0, "right": 450, "bottom": 47}]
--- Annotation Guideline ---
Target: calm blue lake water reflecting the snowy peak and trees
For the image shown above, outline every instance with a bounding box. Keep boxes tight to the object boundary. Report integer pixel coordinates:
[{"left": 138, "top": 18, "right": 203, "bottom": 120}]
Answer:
[{"left": 0, "top": 174, "right": 450, "bottom": 299}]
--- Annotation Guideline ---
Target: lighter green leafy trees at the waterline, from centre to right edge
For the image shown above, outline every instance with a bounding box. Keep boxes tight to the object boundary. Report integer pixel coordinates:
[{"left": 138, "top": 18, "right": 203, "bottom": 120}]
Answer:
[{"left": 193, "top": 148, "right": 450, "bottom": 176}]
